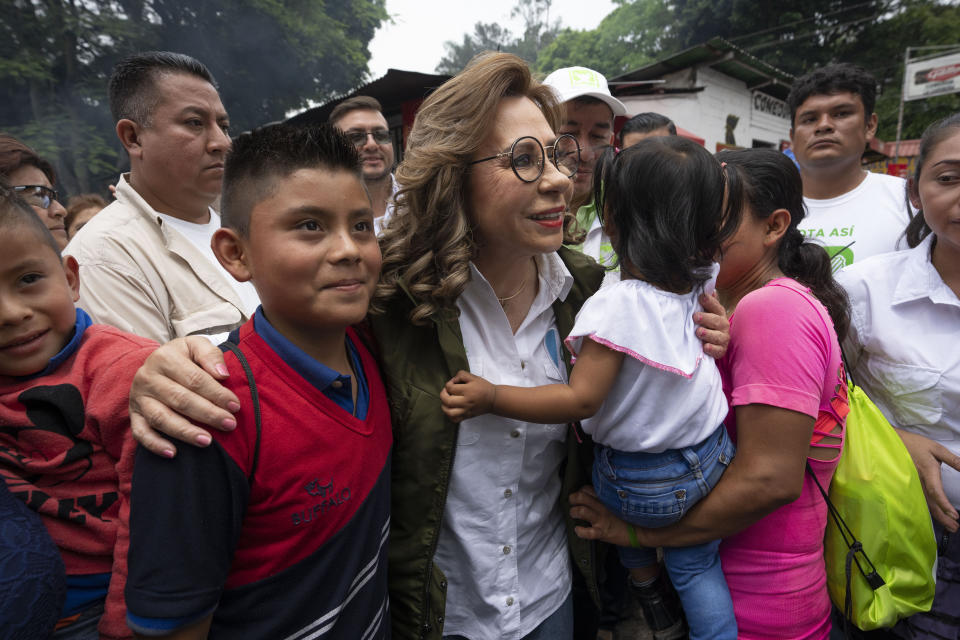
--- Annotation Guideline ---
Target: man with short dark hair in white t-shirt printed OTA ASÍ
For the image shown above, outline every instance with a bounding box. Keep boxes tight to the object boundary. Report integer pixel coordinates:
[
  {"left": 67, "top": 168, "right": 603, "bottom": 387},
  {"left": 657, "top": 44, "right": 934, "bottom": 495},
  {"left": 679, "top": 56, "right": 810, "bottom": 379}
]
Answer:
[{"left": 787, "top": 64, "right": 910, "bottom": 271}]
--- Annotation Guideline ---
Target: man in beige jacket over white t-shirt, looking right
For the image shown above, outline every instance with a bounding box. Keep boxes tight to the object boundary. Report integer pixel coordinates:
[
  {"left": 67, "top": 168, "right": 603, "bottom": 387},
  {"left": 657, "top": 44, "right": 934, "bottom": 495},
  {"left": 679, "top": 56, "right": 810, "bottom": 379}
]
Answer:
[{"left": 64, "top": 51, "right": 259, "bottom": 343}]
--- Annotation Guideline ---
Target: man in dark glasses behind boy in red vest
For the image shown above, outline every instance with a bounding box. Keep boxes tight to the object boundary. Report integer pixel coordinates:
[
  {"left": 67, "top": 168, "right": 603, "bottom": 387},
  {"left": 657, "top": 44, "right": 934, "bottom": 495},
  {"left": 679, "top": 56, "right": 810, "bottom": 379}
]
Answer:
[{"left": 328, "top": 96, "right": 397, "bottom": 235}]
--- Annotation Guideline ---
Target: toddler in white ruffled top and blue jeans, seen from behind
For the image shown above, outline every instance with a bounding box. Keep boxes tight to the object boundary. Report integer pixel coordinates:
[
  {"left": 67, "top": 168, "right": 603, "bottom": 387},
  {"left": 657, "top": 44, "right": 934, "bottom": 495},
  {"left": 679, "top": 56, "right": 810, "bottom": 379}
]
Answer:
[{"left": 441, "top": 137, "right": 740, "bottom": 640}]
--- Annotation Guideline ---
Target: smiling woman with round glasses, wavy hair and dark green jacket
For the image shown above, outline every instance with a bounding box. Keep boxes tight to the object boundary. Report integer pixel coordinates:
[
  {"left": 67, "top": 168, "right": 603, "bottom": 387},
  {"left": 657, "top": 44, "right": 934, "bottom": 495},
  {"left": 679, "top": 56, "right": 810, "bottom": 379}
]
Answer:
[{"left": 124, "top": 54, "right": 727, "bottom": 640}]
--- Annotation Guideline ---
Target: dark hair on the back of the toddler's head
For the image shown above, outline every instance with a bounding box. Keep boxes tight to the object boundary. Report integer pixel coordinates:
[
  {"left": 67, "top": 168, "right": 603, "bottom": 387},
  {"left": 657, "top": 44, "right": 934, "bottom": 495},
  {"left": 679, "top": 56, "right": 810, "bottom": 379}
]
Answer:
[{"left": 593, "top": 136, "right": 740, "bottom": 293}]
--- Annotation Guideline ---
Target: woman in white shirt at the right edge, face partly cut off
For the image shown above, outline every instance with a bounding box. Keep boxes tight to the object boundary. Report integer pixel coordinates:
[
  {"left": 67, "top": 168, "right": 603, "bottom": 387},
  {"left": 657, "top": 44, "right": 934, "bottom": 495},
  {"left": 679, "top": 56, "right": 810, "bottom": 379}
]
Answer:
[{"left": 837, "top": 114, "right": 960, "bottom": 638}]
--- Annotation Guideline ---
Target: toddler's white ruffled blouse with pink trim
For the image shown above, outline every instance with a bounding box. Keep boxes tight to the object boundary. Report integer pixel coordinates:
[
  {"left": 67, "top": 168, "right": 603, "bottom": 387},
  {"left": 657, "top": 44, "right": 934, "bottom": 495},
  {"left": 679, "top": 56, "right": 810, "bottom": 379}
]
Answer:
[{"left": 566, "top": 270, "right": 727, "bottom": 453}]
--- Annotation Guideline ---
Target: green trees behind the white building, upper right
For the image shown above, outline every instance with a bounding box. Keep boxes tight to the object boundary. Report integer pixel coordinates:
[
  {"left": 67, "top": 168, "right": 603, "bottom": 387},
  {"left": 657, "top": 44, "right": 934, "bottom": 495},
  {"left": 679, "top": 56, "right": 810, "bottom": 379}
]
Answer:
[{"left": 535, "top": 0, "right": 960, "bottom": 140}]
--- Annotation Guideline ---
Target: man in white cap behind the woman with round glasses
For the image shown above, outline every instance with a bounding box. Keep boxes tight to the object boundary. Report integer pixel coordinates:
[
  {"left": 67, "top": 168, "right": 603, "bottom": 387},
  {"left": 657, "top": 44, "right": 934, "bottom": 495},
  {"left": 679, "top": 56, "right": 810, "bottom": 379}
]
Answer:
[{"left": 543, "top": 67, "right": 627, "bottom": 284}]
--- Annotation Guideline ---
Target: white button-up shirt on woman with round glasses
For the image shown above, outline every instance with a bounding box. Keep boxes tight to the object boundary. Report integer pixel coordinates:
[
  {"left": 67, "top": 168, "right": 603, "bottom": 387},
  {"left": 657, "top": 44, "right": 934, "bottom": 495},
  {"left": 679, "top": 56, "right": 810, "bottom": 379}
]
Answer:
[{"left": 435, "top": 253, "right": 573, "bottom": 640}]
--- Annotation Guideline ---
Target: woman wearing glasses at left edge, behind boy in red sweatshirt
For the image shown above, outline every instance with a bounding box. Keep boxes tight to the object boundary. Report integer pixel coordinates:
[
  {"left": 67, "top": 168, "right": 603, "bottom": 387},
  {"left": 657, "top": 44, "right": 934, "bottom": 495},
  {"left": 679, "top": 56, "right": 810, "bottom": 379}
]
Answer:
[{"left": 0, "top": 134, "right": 67, "bottom": 249}]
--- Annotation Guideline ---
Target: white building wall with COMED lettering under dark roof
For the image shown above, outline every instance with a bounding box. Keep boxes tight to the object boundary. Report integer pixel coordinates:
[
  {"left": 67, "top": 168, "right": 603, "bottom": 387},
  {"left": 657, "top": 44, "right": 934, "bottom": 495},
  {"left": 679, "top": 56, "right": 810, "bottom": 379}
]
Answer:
[{"left": 621, "top": 67, "right": 790, "bottom": 152}]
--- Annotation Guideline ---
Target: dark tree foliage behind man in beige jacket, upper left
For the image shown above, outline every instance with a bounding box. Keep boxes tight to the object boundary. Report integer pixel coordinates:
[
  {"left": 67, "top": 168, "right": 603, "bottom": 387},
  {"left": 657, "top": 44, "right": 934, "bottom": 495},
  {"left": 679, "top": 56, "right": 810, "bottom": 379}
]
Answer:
[{"left": 0, "top": 0, "right": 387, "bottom": 193}]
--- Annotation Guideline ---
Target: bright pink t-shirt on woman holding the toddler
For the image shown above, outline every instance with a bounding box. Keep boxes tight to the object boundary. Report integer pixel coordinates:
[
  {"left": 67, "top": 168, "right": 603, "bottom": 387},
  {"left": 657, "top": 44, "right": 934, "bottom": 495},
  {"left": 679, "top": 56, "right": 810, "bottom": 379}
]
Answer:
[{"left": 719, "top": 278, "right": 848, "bottom": 640}]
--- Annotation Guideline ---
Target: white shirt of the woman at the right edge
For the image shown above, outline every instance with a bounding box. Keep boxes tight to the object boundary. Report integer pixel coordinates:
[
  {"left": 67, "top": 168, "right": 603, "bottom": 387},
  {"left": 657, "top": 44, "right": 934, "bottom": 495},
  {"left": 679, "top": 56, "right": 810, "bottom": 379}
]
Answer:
[{"left": 837, "top": 235, "right": 960, "bottom": 507}]
